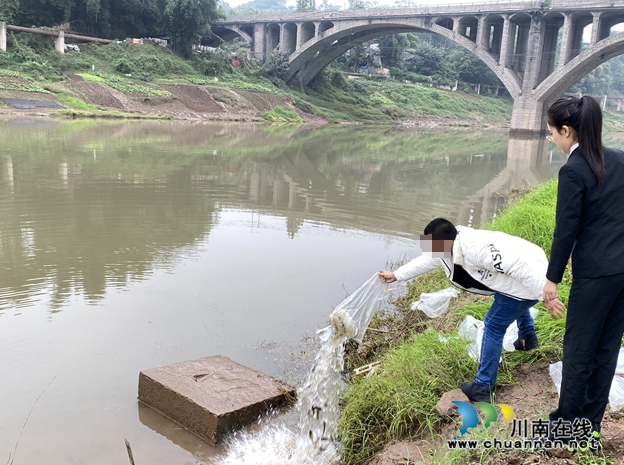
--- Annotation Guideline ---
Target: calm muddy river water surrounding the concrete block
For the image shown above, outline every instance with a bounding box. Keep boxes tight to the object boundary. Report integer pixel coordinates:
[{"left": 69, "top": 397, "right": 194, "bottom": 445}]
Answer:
[{"left": 0, "top": 119, "right": 624, "bottom": 465}]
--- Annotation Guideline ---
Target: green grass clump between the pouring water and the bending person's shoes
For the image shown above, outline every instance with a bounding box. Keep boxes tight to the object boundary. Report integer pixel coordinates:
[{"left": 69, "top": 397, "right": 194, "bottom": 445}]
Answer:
[{"left": 339, "top": 330, "right": 477, "bottom": 464}]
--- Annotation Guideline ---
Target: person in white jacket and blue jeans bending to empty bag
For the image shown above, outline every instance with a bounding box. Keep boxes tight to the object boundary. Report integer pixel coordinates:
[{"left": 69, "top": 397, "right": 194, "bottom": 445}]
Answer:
[{"left": 378, "top": 218, "right": 565, "bottom": 402}]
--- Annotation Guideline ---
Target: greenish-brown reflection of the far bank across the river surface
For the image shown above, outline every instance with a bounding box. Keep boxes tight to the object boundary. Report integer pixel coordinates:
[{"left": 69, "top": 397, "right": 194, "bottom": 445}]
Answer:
[{"left": 0, "top": 121, "right": 532, "bottom": 311}]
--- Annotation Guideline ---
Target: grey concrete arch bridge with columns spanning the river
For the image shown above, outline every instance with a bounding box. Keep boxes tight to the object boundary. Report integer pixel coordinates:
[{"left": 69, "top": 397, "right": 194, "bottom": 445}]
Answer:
[{"left": 210, "top": 0, "right": 624, "bottom": 134}]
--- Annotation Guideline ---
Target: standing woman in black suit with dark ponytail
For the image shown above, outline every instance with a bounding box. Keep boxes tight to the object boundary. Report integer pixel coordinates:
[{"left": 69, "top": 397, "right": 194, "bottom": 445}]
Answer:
[{"left": 543, "top": 96, "right": 624, "bottom": 440}]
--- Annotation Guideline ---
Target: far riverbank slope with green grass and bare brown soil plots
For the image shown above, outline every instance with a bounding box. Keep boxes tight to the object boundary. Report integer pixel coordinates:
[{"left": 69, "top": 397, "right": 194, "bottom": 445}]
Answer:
[{"left": 0, "top": 33, "right": 513, "bottom": 127}]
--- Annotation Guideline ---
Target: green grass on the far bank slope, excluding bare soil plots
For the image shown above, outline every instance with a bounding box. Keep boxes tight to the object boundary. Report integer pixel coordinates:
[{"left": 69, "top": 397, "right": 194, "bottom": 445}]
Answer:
[{"left": 0, "top": 32, "right": 512, "bottom": 126}]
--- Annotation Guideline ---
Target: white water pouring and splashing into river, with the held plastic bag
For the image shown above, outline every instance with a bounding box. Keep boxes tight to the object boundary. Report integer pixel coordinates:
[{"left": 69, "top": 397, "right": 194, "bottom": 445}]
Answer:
[{"left": 216, "top": 274, "right": 388, "bottom": 465}]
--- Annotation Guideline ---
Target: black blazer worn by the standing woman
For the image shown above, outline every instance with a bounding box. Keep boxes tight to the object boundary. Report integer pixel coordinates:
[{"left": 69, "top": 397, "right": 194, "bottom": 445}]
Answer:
[{"left": 546, "top": 147, "right": 624, "bottom": 283}]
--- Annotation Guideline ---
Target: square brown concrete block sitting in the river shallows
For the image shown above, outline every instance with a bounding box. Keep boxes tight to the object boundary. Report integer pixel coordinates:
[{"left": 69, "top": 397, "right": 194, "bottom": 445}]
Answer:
[{"left": 139, "top": 355, "right": 295, "bottom": 444}]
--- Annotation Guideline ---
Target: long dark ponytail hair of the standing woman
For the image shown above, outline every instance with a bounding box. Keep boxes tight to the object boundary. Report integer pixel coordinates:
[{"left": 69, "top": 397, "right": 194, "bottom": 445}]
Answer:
[{"left": 548, "top": 95, "right": 607, "bottom": 184}]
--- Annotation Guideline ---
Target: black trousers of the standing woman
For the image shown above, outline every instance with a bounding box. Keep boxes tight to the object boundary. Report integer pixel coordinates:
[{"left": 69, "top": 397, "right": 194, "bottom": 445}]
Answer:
[{"left": 550, "top": 273, "right": 624, "bottom": 432}]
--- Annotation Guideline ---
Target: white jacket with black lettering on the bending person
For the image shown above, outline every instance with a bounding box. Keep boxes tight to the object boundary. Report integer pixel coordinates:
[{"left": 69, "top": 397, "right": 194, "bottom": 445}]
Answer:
[{"left": 394, "top": 226, "right": 548, "bottom": 300}]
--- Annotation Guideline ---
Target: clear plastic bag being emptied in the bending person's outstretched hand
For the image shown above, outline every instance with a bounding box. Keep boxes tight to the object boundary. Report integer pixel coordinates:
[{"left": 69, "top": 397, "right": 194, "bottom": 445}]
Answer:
[{"left": 329, "top": 273, "right": 389, "bottom": 342}]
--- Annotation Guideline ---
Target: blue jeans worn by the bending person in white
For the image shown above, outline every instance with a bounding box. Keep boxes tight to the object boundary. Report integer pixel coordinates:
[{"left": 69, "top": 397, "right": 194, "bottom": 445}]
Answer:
[{"left": 475, "top": 292, "right": 538, "bottom": 386}]
